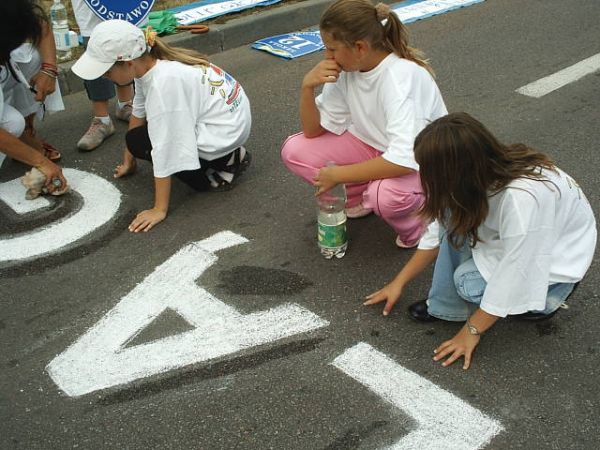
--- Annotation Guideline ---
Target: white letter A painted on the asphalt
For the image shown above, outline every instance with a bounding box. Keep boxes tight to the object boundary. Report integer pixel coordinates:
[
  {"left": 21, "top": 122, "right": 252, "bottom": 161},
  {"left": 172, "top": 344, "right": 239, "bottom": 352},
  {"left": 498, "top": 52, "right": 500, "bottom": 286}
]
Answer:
[{"left": 46, "top": 231, "right": 329, "bottom": 396}]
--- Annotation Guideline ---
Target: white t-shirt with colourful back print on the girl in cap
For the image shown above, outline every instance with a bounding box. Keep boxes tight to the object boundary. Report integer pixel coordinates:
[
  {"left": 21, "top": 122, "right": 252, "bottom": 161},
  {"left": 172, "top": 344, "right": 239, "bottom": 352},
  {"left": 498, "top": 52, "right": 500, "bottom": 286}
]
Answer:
[{"left": 133, "top": 60, "right": 251, "bottom": 178}]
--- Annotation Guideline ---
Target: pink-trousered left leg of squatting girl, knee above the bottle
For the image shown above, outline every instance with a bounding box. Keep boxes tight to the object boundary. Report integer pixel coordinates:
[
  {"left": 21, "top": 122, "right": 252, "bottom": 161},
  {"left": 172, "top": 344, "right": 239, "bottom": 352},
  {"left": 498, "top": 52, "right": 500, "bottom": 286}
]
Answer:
[{"left": 281, "top": 132, "right": 380, "bottom": 208}]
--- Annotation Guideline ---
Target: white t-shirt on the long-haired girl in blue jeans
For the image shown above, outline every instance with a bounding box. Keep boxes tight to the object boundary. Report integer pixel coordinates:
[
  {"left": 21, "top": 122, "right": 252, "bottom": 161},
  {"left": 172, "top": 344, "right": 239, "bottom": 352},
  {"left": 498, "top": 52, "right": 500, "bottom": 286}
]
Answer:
[{"left": 419, "top": 169, "right": 596, "bottom": 317}]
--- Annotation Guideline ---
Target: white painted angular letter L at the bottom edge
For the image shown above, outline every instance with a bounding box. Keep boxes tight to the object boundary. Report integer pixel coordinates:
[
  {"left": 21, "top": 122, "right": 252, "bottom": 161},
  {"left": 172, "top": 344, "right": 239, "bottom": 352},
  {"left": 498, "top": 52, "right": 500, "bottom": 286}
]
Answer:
[{"left": 332, "top": 342, "right": 503, "bottom": 450}]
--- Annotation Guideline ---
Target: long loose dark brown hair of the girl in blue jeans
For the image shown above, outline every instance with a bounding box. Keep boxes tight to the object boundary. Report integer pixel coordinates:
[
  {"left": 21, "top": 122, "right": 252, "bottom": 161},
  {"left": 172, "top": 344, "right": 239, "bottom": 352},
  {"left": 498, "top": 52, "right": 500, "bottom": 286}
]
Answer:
[{"left": 414, "top": 112, "right": 555, "bottom": 247}]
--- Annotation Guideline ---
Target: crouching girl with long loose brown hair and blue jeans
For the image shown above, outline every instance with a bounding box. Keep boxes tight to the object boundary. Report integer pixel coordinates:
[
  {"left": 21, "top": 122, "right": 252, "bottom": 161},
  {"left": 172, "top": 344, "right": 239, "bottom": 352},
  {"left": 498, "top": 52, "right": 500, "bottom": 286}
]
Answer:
[{"left": 365, "top": 113, "right": 596, "bottom": 369}]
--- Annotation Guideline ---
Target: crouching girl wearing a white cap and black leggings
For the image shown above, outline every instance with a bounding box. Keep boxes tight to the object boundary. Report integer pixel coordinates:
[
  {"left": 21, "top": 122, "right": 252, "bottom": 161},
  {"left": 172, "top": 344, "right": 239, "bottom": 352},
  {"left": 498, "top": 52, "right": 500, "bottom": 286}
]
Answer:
[{"left": 72, "top": 20, "right": 251, "bottom": 232}]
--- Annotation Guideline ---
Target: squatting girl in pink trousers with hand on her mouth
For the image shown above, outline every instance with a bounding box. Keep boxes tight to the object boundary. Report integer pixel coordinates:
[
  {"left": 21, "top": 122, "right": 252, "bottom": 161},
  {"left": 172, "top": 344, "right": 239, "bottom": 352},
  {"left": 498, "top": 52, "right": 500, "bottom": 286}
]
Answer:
[{"left": 282, "top": 0, "right": 447, "bottom": 248}]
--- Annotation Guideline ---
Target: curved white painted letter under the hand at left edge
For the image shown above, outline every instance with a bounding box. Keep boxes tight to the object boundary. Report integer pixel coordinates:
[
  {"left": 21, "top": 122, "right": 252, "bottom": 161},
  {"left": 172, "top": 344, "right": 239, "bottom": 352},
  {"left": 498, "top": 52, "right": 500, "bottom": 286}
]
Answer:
[{"left": 0, "top": 169, "right": 121, "bottom": 262}]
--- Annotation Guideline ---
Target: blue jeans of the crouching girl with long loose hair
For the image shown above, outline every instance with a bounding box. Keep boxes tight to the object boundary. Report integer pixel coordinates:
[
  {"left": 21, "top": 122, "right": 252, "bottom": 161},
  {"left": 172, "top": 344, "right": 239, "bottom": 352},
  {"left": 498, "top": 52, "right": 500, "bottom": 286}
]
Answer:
[{"left": 427, "top": 233, "right": 575, "bottom": 322}]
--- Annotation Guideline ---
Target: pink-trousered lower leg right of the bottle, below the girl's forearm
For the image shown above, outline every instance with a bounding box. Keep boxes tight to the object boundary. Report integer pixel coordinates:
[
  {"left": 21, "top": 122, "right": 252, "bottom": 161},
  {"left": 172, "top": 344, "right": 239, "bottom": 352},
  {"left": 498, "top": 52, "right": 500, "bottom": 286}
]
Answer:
[{"left": 363, "top": 172, "right": 426, "bottom": 247}]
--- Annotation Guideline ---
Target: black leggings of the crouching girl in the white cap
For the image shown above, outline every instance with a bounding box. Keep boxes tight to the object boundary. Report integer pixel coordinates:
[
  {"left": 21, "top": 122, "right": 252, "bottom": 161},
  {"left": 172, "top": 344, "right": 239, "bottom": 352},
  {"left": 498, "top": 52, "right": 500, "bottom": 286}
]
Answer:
[{"left": 125, "top": 125, "right": 231, "bottom": 191}]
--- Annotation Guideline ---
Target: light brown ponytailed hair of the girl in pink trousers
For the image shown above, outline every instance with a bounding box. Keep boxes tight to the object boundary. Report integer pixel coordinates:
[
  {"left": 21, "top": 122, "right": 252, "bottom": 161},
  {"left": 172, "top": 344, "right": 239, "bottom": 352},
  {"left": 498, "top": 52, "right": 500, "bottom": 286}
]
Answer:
[{"left": 319, "top": 0, "right": 433, "bottom": 75}]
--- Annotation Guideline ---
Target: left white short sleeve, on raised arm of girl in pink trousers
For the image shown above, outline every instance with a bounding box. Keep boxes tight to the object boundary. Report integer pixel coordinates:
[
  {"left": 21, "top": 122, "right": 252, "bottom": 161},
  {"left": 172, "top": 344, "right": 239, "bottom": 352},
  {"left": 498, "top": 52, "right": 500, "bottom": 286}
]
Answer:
[{"left": 315, "top": 81, "right": 351, "bottom": 135}]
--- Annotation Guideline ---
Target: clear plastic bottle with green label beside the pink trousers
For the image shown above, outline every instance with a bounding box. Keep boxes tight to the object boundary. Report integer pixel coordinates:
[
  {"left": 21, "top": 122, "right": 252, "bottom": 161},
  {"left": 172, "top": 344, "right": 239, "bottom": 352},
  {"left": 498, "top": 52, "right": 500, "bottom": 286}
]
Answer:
[{"left": 317, "top": 178, "right": 348, "bottom": 259}]
